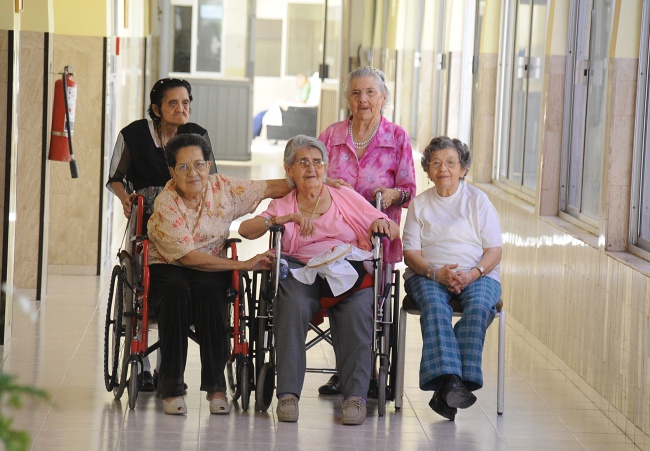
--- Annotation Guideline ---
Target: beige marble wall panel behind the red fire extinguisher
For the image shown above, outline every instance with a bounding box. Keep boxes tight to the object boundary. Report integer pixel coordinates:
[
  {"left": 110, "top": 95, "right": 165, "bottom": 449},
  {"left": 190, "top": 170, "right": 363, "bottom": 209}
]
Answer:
[{"left": 49, "top": 35, "right": 104, "bottom": 274}]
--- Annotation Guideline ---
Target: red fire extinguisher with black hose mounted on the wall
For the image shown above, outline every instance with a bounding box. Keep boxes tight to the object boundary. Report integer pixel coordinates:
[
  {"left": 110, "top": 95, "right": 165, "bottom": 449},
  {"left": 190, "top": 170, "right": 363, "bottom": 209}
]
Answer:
[{"left": 49, "top": 66, "right": 79, "bottom": 179}]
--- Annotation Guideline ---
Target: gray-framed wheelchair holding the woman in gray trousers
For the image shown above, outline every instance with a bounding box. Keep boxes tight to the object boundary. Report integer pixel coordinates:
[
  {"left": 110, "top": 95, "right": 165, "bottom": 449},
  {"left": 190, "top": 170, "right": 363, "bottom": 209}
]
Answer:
[{"left": 252, "top": 193, "right": 400, "bottom": 416}]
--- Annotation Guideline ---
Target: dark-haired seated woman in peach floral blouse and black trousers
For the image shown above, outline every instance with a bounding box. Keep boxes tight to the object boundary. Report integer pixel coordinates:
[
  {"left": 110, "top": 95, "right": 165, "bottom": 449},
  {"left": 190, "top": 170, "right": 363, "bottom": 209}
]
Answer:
[{"left": 148, "top": 134, "right": 289, "bottom": 415}]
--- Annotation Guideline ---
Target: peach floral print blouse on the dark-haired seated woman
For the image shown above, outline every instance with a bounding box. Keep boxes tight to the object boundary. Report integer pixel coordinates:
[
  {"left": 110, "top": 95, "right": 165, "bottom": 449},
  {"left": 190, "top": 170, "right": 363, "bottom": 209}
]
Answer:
[{"left": 148, "top": 174, "right": 266, "bottom": 264}]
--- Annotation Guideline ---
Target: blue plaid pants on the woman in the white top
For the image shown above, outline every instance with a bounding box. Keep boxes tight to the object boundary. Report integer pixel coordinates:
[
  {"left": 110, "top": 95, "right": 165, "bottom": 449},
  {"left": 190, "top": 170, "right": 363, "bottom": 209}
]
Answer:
[{"left": 404, "top": 275, "right": 501, "bottom": 390}]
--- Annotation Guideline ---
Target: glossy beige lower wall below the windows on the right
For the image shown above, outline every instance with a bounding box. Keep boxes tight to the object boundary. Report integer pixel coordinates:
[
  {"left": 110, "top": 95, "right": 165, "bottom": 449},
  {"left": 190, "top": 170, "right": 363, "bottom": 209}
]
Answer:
[{"left": 480, "top": 177, "right": 650, "bottom": 440}]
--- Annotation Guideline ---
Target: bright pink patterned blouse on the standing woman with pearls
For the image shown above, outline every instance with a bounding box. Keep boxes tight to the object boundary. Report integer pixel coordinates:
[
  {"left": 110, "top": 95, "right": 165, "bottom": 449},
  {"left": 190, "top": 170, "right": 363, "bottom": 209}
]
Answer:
[{"left": 318, "top": 116, "right": 415, "bottom": 263}]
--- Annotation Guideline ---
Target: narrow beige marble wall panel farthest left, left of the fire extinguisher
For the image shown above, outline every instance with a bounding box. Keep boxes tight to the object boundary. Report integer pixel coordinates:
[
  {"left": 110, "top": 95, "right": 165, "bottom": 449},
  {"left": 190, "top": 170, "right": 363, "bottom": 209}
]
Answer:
[{"left": 14, "top": 31, "right": 45, "bottom": 289}]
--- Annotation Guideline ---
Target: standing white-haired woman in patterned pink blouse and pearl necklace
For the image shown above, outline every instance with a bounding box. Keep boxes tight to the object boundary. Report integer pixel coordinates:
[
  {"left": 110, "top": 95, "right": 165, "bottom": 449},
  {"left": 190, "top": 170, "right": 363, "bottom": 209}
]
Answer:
[{"left": 318, "top": 66, "right": 415, "bottom": 395}]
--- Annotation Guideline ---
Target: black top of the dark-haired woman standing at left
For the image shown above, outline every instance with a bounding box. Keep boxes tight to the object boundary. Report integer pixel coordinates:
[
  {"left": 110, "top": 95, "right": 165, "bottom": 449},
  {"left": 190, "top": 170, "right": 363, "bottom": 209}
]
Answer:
[{"left": 106, "top": 119, "right": 217, "bottom": 193}]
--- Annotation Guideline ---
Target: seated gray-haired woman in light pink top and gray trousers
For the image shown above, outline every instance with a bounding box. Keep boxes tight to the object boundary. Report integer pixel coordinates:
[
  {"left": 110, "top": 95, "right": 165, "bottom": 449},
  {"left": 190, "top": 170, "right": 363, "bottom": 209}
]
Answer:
[{"left": 239, "top": 135, "right": 399, "bottom": 424}]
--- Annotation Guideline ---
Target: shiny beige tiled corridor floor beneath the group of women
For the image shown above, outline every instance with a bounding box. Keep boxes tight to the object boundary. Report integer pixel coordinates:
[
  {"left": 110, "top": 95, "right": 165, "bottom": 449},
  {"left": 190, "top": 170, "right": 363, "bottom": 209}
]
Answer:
[{"left": 0, "top": 139, "right": 638, "bottom": 451}]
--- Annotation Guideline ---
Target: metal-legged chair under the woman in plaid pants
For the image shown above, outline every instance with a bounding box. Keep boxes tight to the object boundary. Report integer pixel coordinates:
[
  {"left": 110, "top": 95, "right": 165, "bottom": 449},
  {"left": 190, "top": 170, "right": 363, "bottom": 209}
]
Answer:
[{"left": 395, "top": 295, "right": 506, "bottom": 415}]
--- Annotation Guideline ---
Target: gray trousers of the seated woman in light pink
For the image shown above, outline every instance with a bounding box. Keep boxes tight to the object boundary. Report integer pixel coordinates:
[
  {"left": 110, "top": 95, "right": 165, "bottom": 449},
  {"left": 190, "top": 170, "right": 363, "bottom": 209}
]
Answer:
[{"left": 273, "top": 261, "right": 374, "bottom": 398}]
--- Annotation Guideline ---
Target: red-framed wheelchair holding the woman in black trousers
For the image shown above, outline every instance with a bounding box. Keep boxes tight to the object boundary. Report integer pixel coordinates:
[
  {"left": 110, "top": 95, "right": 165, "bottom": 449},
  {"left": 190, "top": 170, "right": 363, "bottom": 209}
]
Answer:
[{"left": 104, "top": 196, "right": 253, "bottom": 410}]
